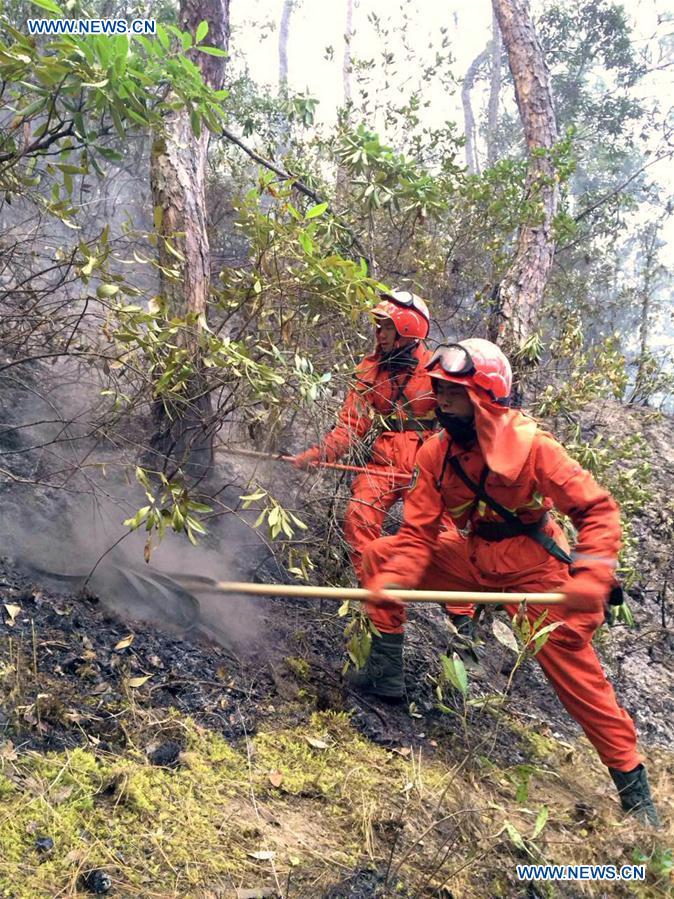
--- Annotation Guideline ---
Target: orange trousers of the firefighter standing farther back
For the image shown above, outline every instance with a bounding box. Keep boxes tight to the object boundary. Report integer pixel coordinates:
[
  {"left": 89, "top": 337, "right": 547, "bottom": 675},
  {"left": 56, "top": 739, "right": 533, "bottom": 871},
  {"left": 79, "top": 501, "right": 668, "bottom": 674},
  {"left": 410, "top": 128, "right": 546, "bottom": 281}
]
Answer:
[{"left": 344, "top": 473, "right": 412, "bottom": 584}]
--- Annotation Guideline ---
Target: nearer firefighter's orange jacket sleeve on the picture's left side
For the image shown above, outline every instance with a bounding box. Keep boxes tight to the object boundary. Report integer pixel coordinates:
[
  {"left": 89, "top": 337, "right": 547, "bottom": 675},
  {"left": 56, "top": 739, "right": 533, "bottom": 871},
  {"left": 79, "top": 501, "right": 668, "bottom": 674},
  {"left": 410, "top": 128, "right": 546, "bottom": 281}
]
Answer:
[{"left": 368, "top": 435, "right": 445, "bottom": 590}]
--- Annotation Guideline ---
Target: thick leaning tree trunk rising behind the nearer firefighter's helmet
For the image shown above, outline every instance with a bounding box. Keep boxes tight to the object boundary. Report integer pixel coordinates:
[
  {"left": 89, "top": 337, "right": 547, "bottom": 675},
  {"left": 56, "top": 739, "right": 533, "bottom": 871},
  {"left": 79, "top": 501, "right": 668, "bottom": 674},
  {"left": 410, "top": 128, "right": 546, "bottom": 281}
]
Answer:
[{"left": 490, "top": 0, "right": 559, "bottom": 352}]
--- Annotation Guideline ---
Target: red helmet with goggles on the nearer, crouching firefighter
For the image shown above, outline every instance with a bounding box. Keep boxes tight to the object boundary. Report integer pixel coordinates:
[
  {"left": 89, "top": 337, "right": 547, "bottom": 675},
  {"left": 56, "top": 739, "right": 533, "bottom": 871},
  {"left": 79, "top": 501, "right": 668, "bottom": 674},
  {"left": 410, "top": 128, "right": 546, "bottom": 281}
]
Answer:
[{"left": 426, "top": 337, "right": 513, "bottom": 403}]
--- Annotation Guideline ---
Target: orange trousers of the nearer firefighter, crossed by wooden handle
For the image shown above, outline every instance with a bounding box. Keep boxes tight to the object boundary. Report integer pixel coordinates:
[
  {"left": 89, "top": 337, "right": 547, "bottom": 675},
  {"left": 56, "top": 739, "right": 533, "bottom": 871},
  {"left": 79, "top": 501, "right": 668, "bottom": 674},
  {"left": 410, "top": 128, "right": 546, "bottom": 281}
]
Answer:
[{"left": 363, "top": 531, "right": 643, "bottom": 771}]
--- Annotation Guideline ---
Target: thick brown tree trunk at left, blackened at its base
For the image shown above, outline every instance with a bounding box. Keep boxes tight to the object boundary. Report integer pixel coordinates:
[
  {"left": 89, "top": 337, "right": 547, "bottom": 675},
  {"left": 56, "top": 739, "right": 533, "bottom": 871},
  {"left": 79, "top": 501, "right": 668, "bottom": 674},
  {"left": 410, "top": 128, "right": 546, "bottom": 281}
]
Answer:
[{"left": 150, "top": 0, "right": 229, "bottom": 477}]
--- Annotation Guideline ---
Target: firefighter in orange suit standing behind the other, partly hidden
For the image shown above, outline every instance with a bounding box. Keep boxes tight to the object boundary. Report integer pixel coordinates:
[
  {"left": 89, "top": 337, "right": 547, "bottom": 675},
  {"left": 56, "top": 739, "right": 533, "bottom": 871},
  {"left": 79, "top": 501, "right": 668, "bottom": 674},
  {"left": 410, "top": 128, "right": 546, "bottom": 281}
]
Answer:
[{"left": 294, "top": 290, "right": 437, "bottom": 580}]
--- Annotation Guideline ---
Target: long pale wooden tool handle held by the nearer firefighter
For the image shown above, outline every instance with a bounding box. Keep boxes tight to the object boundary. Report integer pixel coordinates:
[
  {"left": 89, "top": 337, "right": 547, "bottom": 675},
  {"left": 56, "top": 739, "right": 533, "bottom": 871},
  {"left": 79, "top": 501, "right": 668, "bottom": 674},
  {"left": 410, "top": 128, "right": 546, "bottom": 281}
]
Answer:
[{"left": 175, "top": 575, "right": 564, "bottom": 606}]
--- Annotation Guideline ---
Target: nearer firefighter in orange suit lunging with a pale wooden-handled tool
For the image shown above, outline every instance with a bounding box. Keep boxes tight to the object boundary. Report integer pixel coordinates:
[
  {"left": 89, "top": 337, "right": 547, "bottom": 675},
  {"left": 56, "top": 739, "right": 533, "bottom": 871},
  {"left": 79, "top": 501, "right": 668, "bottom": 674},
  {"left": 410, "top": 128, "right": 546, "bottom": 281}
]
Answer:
[{"left": 352, "top": 338, "right": 658, "bottom": 826}]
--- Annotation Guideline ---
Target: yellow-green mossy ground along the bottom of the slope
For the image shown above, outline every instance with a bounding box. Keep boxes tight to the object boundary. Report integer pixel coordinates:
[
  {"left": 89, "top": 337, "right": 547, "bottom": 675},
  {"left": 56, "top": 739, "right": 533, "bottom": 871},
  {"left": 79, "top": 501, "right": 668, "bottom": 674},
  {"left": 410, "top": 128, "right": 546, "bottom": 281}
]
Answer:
[{"left": 0, "top": 712, "right": 655, "bottom": 899}]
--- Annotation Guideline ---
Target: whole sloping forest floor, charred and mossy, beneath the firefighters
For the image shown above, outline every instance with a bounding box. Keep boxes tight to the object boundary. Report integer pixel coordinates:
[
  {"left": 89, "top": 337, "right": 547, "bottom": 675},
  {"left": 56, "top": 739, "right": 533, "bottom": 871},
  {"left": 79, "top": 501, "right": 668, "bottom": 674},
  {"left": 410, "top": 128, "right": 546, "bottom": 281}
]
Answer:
[{"left": 0, "top": 404, "right": 674, "bottom": 899}]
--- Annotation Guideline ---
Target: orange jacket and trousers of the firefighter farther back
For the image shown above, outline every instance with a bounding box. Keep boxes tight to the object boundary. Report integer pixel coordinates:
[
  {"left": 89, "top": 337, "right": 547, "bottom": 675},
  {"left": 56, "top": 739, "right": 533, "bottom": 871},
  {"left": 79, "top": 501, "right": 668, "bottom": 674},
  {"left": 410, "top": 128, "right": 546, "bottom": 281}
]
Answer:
[{"left": 319, "top": 343, "right": 435, "bottom": 580}]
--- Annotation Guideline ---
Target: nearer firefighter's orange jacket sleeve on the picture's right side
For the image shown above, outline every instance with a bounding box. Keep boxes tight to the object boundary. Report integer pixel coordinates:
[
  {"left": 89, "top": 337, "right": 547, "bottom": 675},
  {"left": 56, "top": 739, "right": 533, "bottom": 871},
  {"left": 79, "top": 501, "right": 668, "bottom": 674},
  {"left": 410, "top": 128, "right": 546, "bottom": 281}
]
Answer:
[{"left": 533, "top": 432, "right": 621, "bottom": 585}]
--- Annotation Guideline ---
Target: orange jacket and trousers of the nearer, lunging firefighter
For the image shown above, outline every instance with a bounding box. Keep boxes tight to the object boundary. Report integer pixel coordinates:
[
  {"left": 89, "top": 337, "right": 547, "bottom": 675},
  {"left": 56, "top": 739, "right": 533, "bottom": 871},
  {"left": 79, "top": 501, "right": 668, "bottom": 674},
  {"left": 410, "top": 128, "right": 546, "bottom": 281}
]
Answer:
[{"left": 363, "top": 426, "right": 642, "bottom": 771}]
